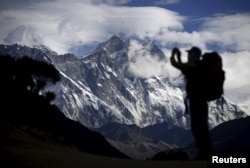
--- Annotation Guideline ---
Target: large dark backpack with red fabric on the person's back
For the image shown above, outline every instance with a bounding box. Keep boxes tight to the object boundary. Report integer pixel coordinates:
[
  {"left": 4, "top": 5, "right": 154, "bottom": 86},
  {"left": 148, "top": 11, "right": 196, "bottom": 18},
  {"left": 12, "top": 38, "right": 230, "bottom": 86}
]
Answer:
[{"left": 189, "top": 52, "right": 225, "bottom": 101}]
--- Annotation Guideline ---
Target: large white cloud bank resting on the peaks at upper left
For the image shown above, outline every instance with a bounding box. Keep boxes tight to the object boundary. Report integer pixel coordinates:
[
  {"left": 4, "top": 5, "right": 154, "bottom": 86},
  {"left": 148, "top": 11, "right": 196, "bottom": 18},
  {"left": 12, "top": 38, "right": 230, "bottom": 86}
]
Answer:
[{"left": 0, "top": 0, "right": 184, "bottom": 53}]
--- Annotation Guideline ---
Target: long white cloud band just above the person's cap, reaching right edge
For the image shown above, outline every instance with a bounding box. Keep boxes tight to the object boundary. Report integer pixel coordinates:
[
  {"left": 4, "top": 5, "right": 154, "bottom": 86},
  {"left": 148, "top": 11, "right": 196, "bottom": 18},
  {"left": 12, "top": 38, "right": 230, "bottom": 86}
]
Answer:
[{"left": 151, "top": 13, "right": 250, "bottom": 52}]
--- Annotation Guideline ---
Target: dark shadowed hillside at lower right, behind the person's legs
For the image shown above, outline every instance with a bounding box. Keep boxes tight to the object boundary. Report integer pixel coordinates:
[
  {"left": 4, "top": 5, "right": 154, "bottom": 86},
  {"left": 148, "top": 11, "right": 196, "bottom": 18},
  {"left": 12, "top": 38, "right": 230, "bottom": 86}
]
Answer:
[{"left": 150, "top": 116, "right": 250, "bottom": 160}]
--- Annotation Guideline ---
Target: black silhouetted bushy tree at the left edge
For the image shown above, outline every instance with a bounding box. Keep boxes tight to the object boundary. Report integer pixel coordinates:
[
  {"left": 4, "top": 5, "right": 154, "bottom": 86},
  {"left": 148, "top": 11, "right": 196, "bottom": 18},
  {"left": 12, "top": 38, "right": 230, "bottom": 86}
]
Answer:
[{"left": 0, "top": 55, "right": 60, "bottom": 119}]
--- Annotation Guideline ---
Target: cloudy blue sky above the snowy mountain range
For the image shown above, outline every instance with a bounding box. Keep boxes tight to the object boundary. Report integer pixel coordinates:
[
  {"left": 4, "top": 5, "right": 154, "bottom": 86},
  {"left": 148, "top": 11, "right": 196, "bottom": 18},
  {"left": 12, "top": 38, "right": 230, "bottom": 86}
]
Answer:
[{"left": 0, "top": 0, "right": 250, "bottom": 105}]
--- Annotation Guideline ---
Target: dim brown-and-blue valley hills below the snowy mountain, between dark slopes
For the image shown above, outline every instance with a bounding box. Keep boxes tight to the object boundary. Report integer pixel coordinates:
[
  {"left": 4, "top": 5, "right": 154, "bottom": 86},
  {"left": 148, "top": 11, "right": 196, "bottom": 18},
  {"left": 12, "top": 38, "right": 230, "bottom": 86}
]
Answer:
[{"left": 93, "top": 123, "right": 193, "bottom": 160}]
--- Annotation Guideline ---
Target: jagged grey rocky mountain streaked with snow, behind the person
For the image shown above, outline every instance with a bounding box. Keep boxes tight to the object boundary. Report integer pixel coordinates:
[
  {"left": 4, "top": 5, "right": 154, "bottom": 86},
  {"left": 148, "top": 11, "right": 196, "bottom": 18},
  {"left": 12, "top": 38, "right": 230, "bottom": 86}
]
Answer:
[{"left": 0, "top": 35, "right": 246, "bottom": 129}]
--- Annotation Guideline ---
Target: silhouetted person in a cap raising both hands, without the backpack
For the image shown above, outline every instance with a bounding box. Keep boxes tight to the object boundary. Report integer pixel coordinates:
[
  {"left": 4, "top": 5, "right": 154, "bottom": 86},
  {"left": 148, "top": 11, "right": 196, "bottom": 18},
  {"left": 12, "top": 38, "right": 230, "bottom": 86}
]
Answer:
[{"left": 170, "top": 47, "right": 212, "bottom": 159}]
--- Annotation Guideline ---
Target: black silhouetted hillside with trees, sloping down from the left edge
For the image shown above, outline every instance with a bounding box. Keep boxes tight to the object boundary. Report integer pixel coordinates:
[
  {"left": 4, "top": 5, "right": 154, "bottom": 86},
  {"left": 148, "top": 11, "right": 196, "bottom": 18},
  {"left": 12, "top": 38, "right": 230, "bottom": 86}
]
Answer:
[{"left": 0, "top": 56, "right": 128, "bottom": 158}]
